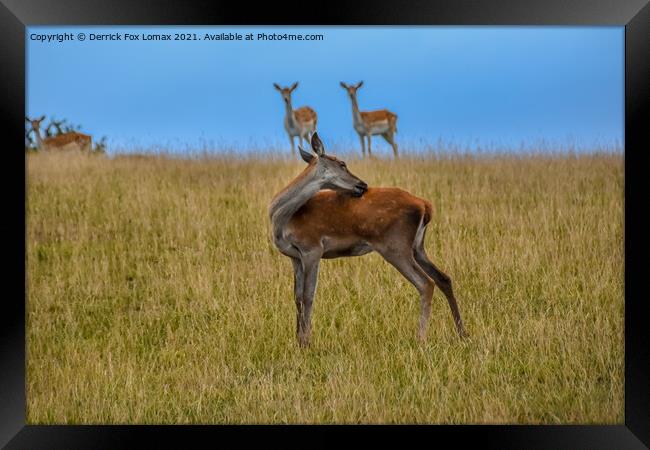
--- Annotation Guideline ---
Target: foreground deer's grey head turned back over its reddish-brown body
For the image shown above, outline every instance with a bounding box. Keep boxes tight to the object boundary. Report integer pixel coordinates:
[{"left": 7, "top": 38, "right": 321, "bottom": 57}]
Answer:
[{"left": 298, "top": 133, "right": 368, "bottom": 197}]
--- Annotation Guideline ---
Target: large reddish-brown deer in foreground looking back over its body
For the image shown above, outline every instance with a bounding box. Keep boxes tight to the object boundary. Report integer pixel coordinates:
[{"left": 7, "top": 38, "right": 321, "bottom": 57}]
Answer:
[{"left": 268, "top": 133, "right": 468, "bottom": 348}]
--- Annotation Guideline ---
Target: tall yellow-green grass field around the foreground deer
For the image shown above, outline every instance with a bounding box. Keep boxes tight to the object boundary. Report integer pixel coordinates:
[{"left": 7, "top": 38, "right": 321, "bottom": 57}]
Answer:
[{"left": 27, "top": 149, "right": 624, "bottom": 424}]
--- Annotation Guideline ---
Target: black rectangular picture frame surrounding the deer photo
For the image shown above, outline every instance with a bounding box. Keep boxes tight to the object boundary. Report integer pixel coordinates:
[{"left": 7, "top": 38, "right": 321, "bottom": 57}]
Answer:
[{"left": 0, "top": 0, "right": 650, "bottom": 449}]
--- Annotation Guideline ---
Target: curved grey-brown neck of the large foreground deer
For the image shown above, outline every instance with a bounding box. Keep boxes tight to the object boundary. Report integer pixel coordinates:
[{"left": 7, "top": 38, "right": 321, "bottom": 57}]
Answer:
[{"left": 269, "top": 165, "right": 322, "bottom": 242}]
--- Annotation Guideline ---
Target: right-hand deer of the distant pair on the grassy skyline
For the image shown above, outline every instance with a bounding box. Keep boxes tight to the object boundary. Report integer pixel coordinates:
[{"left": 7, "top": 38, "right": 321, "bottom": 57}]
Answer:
[{"left": 341, "top": 81, "right": 399, "bottom": 158}]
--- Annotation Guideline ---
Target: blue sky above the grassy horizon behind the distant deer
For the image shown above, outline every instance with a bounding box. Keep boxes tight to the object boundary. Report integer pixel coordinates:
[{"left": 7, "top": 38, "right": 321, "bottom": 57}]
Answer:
[{"left": 26, "top": 26, "right": 624, "bottom": 156}]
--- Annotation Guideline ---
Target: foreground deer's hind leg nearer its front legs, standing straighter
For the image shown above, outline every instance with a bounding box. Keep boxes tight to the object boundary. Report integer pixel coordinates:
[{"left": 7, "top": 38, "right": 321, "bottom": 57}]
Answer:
[{"left": 378, "top": 246, "right": 435, "bottom": 341}]
